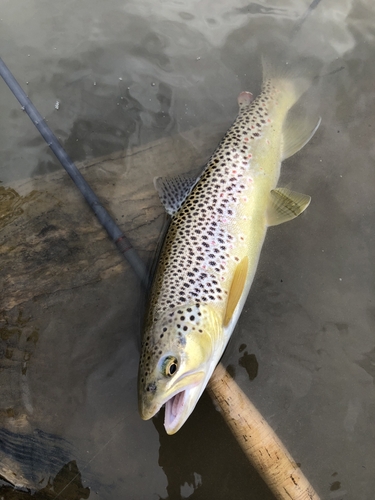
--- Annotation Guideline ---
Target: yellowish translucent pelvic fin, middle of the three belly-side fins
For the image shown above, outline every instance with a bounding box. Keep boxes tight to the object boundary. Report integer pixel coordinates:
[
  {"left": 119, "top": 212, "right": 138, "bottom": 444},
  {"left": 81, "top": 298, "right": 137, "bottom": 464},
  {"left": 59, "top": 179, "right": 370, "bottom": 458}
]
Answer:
[{"left": 267, "top": 188, "right": 311, "bottom": 226}]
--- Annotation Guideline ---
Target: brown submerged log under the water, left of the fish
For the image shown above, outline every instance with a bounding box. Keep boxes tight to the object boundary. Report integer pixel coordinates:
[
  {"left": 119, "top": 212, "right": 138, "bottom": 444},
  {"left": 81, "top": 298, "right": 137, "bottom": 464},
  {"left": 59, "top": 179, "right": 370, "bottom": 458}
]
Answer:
[{"left": 0, "top": 126, "right": 226, "bottom": 311}]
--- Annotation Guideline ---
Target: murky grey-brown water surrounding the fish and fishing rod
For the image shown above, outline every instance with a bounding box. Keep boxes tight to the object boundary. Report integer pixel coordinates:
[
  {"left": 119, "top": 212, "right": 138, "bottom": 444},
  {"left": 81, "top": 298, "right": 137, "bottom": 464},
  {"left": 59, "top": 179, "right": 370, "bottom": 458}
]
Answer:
[{"left": 0, "top": 0, "right": 375, "bottom": 500}]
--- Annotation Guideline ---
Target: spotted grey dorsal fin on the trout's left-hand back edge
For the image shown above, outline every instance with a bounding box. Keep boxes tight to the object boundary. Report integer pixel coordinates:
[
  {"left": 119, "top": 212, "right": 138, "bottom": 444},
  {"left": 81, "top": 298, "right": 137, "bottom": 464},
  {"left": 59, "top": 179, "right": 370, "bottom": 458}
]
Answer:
[{"left": 154, "top": 175, "right": 198, "bottom": 215}]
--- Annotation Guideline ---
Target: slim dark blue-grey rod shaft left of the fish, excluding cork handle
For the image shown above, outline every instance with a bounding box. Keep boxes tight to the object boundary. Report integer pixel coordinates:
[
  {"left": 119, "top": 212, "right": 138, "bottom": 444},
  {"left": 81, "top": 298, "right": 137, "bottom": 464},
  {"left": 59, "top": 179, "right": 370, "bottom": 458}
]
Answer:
[{"left": 0, "top": 57, "right": 148, "bottom": 286}]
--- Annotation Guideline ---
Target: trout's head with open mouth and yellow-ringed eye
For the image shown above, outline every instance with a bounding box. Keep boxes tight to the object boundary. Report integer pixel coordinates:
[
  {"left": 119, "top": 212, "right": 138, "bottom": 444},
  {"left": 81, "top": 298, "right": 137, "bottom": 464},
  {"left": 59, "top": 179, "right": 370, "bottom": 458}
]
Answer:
[{"left": 138, "top": 304, "right": 223, "bottom": 434}]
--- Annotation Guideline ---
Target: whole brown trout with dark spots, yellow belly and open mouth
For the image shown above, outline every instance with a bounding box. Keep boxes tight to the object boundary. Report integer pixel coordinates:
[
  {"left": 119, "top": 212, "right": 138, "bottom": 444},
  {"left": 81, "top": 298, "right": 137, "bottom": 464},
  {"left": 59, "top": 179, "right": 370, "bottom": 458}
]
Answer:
[{"left": 138, "top": 59, "right": 320, "bottom": 434}]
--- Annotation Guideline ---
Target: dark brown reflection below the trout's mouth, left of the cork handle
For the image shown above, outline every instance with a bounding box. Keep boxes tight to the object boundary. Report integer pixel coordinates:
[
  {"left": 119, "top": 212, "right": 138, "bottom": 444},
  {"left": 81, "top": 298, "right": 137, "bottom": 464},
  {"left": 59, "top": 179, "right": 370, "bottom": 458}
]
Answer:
[{"left": 153, "top": 393, "right": 274, "bottom": 500}]
